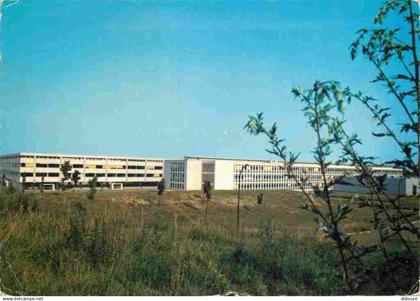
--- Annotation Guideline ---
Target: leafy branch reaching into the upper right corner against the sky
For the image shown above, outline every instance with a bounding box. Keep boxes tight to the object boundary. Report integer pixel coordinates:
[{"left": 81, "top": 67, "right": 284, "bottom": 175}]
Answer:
[{"left": 350, "top": 0, "right": 420, "bottom": 177}]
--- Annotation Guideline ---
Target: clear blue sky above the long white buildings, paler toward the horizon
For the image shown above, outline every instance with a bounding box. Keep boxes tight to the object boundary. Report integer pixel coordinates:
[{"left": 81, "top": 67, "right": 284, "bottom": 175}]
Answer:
[{"left": 0, "top": 0, "right": 414, "bottom": 160}]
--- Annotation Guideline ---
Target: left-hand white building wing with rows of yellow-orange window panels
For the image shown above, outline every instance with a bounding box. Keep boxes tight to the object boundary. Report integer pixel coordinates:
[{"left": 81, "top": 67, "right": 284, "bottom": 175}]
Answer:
[{"left": 0, "top": 153, "right": 164, "bottom": 190}]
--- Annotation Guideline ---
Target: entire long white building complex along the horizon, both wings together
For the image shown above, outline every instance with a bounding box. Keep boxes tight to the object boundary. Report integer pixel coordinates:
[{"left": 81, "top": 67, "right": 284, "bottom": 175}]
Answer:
[{"left": 0, "top": 153, "right": 402, "bottom": 190}]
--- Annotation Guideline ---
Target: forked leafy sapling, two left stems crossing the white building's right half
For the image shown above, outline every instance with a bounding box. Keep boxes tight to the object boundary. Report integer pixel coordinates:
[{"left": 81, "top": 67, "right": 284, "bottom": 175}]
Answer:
[{"left": 245, "top": 82, "right": 355, "bottom": 293}]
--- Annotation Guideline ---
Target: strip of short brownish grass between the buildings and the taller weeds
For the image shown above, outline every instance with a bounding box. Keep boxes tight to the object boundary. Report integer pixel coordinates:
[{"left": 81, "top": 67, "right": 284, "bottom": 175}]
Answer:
[{"left": 30, "top": 190, "right": 371, "bottom": 235}]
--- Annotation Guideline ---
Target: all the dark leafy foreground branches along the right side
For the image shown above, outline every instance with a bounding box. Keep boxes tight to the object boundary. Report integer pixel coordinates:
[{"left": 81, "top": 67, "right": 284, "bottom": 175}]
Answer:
[{"left": 245, "top": 0, "right": 420, "bottom": 293}]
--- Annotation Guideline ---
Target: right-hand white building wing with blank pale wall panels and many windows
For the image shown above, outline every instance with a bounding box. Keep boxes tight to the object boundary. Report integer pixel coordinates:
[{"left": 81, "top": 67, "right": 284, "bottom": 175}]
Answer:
[{"left": 164, "top": 157, "right": 402, "bottom": 190}]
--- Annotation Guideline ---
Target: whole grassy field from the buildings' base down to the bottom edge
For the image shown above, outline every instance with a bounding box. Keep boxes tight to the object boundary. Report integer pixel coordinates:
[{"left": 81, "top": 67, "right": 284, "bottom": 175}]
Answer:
[{"left": 0, "top": 190, "right": 418, "bottom": 295}]
